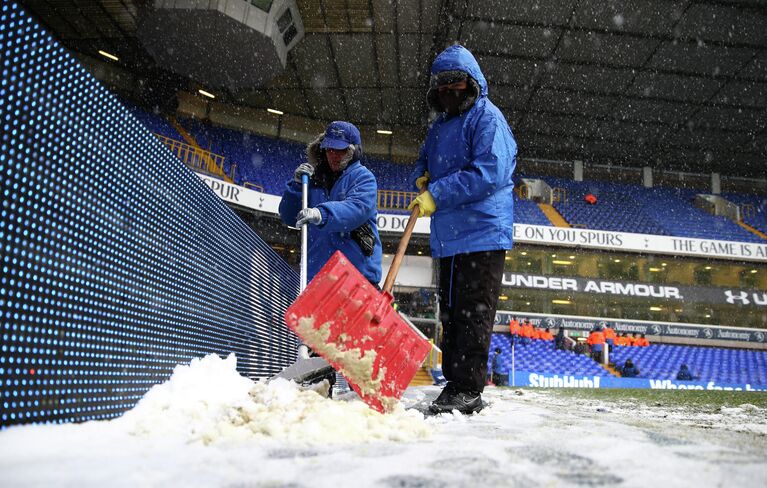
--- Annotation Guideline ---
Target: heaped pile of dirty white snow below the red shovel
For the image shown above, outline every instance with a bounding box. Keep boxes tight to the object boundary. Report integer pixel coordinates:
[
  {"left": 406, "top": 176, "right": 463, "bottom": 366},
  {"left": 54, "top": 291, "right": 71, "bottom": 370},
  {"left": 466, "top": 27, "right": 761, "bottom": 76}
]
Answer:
[{"left": 114, "top": 355, "right": 431, "bottom": 445}]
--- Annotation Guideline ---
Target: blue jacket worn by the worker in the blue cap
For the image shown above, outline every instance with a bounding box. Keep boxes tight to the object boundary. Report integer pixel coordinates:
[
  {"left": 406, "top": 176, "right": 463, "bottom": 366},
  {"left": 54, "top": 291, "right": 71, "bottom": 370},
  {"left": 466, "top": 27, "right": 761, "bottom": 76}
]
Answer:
[{"left": 280, "top": 160, "right": 382, "bottom": 284}]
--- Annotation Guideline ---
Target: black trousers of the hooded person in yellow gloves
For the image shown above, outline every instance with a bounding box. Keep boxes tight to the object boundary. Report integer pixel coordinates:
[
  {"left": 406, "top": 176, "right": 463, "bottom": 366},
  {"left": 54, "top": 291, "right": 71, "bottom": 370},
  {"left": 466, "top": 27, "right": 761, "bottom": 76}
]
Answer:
[{"left": 439, "top": 251, "right": 506, "bottom": 392}]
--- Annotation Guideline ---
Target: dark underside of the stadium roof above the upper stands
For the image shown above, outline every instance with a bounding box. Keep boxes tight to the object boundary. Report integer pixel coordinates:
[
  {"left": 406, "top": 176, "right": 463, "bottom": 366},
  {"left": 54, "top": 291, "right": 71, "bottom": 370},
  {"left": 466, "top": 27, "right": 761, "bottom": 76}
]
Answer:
[{"left": 23, "top": 0, "right": 767, "bottom": 177}]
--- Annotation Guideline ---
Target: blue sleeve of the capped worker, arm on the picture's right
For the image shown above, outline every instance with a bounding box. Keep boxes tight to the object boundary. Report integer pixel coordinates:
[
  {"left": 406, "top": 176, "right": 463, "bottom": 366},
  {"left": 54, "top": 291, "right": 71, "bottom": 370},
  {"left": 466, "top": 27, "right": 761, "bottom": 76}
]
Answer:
[{"left": 317, "top": 171, "right": 378, "bottom": 232}]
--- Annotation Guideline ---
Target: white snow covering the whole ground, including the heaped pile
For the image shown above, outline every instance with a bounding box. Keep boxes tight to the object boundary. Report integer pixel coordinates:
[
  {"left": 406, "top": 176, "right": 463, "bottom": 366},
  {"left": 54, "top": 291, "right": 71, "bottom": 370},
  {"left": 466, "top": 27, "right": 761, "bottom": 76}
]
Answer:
[{"left": 0, "top": 356, "right": 767, "bottom": 488}]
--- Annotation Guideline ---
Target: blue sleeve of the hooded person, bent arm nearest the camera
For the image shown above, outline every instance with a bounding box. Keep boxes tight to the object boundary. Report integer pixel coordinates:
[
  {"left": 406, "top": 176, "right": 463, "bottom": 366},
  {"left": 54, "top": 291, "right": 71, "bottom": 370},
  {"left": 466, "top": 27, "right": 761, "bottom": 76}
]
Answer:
[{"left": 429, "top": 112, "right": 517, "bottom": 210}]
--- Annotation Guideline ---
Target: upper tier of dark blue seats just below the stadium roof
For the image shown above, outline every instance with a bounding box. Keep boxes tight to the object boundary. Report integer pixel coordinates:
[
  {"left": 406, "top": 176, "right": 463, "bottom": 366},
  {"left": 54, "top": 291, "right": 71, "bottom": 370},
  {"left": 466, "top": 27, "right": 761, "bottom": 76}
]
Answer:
[{"left": 123, "top": 108, "right": 767, "bottom": 243}]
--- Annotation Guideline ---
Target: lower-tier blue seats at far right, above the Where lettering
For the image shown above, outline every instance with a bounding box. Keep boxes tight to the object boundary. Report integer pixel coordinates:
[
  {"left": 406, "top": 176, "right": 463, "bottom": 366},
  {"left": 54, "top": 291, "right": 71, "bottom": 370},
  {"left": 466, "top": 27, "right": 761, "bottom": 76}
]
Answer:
[{"left": 610, "top": 344, "right": 767, "bottom": 386}]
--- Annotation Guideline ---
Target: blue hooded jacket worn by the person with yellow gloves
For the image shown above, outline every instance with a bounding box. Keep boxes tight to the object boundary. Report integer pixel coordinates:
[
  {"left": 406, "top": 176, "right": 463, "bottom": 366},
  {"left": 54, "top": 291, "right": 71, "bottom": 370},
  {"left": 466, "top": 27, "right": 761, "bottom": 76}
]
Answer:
[{"left": 410, "top": 46, "right": 517, "bottom": 258}]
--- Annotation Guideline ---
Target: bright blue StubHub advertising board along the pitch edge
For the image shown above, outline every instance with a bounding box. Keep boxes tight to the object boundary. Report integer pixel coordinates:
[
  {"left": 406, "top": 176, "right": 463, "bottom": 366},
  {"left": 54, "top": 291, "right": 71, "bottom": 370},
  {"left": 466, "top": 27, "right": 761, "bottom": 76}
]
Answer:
[{"left": 509, "top": 371, "right": 767, "bottom": 391}]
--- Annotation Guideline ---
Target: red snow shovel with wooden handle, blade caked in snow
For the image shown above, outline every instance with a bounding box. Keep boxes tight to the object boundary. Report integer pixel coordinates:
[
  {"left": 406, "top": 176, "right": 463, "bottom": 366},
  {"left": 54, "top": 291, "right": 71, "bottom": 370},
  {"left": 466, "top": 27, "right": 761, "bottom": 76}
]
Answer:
[{"left": 285, "top": 198, "right": 432, "bottom": 413}]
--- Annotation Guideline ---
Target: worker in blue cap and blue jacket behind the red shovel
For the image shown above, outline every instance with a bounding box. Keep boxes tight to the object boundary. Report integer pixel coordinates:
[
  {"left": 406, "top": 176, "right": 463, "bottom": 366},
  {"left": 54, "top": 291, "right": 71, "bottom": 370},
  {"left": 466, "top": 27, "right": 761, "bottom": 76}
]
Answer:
[{"left": 279, "top": 121, "right": 382, "bottom": 287}]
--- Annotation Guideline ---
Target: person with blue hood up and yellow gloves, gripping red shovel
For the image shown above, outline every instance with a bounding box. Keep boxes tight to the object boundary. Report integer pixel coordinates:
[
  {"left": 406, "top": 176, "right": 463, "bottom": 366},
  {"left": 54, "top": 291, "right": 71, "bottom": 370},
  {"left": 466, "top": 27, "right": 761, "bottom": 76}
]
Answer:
[{"left": 410, "top": 45, "right": 517, "bottom": 414}]
